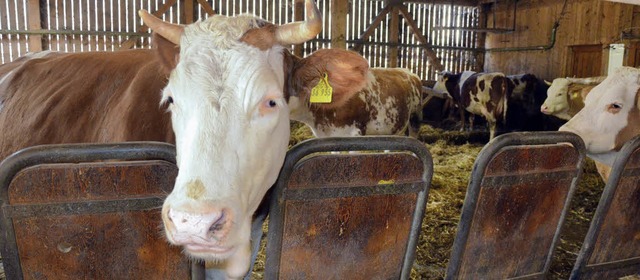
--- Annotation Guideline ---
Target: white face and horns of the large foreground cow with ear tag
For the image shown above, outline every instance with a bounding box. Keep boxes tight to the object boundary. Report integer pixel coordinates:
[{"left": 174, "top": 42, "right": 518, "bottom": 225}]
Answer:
[{"left": 141, "top": 0, "right": 322, "bottom": 278}]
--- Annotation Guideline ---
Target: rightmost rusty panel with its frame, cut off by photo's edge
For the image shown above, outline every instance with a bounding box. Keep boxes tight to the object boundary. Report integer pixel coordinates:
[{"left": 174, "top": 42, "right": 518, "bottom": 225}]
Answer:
[{"left": 571, "top": 137, "right": 640, "bottom": 279}]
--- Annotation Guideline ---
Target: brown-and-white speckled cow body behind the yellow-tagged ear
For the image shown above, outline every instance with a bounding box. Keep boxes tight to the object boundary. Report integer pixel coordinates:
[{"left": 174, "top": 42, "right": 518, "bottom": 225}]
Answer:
[{"left": 291, "top": 67, "right": 422, "bottom": 137}]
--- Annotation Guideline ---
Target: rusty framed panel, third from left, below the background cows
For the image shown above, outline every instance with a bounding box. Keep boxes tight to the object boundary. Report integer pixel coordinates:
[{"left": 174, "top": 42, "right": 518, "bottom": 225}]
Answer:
[{"left": 447, "top": 132, "right": 585, "bottom": 279}]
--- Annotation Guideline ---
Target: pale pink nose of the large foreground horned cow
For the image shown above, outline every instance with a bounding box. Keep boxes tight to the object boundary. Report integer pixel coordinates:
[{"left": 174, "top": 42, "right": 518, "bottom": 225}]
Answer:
[{"left": 167, "top": 209, "right": 227, "bottom": 243}]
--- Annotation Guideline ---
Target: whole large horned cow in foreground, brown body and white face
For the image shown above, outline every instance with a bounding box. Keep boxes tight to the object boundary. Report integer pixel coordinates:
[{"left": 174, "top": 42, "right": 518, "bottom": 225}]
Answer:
[{"left": 0, "top": 0, "right": 376, "bottom": 278}]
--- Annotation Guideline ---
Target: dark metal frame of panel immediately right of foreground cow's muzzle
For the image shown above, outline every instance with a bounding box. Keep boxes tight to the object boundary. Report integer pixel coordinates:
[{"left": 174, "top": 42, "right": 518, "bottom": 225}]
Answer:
[{"left": 265, "top": 136, "right": 433, "bottom": 279}]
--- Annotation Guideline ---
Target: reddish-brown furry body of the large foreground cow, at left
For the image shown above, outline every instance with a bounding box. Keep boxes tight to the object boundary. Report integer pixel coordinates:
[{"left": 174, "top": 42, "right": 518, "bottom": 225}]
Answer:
[{"left": 0, "top": 50, "right": 175, "bottom": 159}]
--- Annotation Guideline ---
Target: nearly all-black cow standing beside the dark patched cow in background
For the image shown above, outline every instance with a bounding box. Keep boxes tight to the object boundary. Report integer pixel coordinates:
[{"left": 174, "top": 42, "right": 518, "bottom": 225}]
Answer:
[{"left": 505, "top": 74, "right": 564, "bottom": 131}]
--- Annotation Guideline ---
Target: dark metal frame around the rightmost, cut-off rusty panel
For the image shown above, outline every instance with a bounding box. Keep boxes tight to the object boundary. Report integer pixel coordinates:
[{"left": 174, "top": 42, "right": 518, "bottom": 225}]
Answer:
[{"left": 569, "top": 136, "right": 640, "bottom": 279}]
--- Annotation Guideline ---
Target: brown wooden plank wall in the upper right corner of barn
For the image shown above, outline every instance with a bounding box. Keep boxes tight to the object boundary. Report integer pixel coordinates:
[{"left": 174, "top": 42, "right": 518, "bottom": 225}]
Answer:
[{"left": 484, "top": 0, "right": 640, "bottom": 79}]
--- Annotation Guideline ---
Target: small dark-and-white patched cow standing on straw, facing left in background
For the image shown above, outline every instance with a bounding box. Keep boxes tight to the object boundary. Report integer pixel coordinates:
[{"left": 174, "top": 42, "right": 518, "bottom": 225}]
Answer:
[{"left": 433, "top": 71, "right": 513, "bottom": 139}]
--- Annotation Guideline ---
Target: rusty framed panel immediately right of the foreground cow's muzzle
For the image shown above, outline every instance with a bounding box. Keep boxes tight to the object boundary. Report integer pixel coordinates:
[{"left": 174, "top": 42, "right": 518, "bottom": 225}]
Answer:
[{"left": 265, "top": 137, "right": 432, "bottom": 279}]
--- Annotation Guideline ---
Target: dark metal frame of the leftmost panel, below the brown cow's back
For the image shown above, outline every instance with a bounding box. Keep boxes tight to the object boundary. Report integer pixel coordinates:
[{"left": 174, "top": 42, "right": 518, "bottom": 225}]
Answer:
[{"left": 0, "top": 142, "right": 204, "bottom": 280}]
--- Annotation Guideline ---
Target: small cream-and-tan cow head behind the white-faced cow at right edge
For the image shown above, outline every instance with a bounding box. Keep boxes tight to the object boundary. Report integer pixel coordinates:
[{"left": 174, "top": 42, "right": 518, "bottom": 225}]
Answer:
[{"left": 540, "top": 76, "right": 606, "bottom": 120}]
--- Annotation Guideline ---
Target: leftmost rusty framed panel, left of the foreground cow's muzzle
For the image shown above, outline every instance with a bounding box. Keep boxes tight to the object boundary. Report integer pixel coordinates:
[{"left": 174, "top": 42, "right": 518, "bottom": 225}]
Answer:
[{"left": 0, "top": 143, "right": 202, "bottom": 279}]
